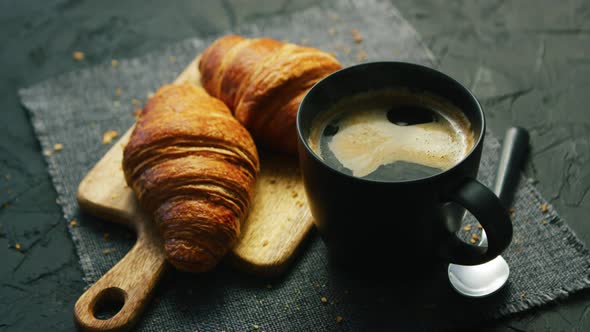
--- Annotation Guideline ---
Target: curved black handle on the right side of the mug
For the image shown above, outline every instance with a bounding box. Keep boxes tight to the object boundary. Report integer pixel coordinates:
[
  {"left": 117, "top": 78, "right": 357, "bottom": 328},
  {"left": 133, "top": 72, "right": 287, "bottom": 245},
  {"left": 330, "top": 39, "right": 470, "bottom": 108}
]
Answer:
[{"left": 448, "top": 178, "right": 512, "bottom": 265}]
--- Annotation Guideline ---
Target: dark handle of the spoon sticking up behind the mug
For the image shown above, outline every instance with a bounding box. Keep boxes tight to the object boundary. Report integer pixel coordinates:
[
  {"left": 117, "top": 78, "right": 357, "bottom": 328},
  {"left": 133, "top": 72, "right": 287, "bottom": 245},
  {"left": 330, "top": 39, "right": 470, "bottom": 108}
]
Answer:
[{"left": 494, "top": 127, "right": 529, "bottom": 204}]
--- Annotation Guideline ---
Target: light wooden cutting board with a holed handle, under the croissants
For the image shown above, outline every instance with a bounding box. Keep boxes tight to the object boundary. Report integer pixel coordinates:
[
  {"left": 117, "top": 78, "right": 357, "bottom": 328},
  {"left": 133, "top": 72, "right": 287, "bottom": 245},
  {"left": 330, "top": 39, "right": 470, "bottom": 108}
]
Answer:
[{"left": 75, "top": 57, "right": 313, "bottom": 331}]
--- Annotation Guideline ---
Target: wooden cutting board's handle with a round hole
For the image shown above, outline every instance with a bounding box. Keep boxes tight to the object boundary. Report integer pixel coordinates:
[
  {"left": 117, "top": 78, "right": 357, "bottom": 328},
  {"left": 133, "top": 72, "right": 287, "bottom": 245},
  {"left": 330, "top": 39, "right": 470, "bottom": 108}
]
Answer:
[{"left": 74, "top": 217, "right": 166, "bottom": 331}]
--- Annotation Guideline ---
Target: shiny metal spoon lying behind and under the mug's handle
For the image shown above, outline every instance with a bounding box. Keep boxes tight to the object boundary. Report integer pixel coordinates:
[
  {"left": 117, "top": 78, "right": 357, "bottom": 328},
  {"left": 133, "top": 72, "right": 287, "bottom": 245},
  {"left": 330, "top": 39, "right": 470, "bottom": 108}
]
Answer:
[{"left": 448, "top": 127, "right": 529, "bottom": 297}]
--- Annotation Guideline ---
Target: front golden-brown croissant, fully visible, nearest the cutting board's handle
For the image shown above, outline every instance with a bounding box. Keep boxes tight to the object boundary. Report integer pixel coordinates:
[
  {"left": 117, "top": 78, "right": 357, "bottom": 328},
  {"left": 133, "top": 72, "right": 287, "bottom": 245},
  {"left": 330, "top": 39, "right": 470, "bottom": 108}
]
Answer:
[{"left": 123, "top": 84, "right": 259, "bottom": 272}]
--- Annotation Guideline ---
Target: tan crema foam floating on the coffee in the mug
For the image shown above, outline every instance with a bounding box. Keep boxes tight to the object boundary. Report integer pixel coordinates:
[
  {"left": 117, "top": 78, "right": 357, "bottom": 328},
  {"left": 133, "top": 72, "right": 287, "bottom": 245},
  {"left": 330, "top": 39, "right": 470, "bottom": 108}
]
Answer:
[{"left": 308, "top": 89, "right": 474, "bottom": 177}]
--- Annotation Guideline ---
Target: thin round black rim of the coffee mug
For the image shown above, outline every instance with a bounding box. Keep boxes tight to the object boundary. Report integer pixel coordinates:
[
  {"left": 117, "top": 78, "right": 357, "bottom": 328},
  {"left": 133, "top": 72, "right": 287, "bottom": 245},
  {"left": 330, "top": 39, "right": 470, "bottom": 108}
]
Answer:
[{"left": 295, "top": 61, "right": 486, "bottom": 184}]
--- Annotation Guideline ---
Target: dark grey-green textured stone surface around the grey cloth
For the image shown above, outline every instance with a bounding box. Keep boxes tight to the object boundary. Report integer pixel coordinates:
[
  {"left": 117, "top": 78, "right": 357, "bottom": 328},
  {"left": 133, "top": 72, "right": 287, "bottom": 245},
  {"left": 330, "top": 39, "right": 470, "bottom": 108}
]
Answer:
[{"left": 0, "top": 0, "right": 590, "bottom": 331}]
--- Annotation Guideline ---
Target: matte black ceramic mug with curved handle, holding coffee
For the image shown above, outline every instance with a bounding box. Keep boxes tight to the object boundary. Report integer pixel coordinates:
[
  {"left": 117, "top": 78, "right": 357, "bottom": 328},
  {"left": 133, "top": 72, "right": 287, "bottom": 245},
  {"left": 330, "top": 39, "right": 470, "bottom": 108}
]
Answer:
[{"left": 297, "top": 62, "right": 512, "bottom": 267}]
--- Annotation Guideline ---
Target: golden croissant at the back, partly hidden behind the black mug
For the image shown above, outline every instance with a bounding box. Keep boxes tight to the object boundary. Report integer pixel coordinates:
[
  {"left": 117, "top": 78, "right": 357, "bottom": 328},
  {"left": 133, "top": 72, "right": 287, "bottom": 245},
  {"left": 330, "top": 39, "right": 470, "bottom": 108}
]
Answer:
[{"left": 199, "top": 35, "right": 341, "bottom": 153}]
